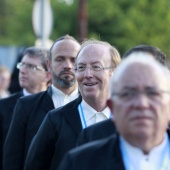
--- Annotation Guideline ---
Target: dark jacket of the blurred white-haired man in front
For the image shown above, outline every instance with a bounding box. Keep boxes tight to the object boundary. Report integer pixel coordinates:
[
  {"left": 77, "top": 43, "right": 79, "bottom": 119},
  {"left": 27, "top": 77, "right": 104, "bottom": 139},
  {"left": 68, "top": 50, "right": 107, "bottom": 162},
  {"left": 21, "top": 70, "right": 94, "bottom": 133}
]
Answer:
[{"left": 56, "top": 135, "right": 125, "bottom": 170}]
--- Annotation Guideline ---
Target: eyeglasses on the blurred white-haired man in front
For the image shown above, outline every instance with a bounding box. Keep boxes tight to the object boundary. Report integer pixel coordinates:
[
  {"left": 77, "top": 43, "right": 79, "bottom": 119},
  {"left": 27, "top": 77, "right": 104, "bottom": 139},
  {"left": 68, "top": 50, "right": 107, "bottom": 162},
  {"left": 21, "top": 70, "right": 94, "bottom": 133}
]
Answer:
[{"left": 112, "top": 89, "right": 170, "bottom": 101}]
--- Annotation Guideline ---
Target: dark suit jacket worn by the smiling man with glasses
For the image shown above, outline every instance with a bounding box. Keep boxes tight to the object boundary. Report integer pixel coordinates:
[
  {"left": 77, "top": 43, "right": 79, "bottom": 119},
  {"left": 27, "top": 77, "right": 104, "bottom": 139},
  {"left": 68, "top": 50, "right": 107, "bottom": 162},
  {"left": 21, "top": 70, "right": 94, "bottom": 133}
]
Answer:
[{"left": 24, "top": 96, "right": 82, "bottom": 170}]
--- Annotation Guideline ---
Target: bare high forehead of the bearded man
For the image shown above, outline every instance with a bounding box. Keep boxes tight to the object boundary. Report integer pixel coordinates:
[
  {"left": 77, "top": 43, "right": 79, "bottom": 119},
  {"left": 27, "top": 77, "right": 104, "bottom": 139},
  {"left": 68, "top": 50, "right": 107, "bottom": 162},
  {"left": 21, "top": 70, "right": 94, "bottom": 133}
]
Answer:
[{"left": 51, "top": 40, "right": 80, "bottom": 57}]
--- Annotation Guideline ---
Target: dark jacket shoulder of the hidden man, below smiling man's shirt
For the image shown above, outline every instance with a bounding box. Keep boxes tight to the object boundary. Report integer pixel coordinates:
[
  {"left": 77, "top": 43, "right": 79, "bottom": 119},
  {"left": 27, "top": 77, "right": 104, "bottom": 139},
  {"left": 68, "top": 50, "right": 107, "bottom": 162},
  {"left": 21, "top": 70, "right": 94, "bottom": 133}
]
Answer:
[{"left": 77, "top": 119, "right": 116, "bottom": 146}]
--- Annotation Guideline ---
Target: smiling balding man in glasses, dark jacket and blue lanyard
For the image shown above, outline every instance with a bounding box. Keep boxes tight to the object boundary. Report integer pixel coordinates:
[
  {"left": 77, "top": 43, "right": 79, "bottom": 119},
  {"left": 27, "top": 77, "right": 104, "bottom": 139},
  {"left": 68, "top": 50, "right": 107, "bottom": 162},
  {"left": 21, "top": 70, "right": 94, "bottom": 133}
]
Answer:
[{"left": 24, "top": 41, "right": 120, "bottom": 170}]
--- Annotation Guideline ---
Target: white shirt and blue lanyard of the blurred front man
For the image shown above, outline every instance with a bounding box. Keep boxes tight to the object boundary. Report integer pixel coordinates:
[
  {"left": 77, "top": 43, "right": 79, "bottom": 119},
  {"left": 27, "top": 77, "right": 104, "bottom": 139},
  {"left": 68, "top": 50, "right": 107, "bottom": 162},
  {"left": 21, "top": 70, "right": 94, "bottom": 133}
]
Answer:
[{"left": 120, "top": 134, "right": 170, "bottom": 170}]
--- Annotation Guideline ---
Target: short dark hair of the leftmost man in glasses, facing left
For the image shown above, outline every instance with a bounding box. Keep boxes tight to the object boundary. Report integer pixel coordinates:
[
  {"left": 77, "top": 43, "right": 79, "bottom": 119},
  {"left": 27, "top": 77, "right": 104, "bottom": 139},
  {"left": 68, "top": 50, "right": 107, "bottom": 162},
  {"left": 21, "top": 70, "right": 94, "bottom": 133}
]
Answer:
[{"left": 23, "top": 47, "right": 49, "bottom": 71}]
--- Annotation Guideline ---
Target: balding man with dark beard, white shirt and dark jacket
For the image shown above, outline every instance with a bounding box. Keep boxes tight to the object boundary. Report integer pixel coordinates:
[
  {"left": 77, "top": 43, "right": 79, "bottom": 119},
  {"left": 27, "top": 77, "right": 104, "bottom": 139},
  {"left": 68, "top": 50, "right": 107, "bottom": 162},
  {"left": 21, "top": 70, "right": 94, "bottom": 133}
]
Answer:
[{"left": 3, "top": 35, "right": 80, "bottom": 170}]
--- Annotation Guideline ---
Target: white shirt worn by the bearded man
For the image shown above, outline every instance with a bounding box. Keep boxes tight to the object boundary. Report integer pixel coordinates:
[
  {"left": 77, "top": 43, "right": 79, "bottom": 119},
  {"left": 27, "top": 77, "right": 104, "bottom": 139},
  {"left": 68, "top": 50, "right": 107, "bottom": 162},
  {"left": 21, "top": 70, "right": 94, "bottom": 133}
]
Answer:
[{"left": 51, "top": 85, "right": 79, "bottom": 108}]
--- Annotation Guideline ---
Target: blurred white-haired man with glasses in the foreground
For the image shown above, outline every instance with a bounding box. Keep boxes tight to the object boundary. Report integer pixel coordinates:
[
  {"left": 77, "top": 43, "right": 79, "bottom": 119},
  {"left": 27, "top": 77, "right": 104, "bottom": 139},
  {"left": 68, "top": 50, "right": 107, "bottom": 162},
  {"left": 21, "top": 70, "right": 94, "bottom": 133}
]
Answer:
[{"left": 57, "top": 46, "right": 170, "bottom": 170}]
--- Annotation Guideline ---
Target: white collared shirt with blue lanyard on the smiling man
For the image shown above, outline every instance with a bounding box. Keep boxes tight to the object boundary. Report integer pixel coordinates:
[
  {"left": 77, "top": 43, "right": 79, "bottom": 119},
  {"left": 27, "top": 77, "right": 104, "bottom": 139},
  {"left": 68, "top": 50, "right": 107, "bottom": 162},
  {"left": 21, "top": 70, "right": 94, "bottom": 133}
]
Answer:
[{"left": 78, "top": 100, "right": 111, "bottom": 128}]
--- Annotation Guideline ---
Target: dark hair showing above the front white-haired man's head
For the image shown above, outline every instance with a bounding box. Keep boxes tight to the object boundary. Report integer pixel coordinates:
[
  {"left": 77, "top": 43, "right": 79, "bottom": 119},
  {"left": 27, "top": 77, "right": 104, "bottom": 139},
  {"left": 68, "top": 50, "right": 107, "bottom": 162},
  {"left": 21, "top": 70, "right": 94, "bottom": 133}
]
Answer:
[{"left": 123, "top": 45, "right": 167, "bottom": 66}]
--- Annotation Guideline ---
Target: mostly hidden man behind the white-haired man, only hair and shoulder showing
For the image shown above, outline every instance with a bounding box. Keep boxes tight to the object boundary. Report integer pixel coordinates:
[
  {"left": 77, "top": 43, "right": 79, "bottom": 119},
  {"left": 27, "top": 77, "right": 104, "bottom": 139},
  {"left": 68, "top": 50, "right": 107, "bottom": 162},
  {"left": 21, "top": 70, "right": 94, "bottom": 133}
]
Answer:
[{"left": 77, "top": 45, "right": 167, "bottom": 146}]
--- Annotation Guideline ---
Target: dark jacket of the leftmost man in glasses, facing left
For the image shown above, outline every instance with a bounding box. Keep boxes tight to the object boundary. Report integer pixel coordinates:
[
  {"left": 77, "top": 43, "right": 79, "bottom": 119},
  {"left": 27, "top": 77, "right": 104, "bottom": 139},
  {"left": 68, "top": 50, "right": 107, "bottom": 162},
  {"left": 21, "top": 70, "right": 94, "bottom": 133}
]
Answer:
[{"left": 0, "top": 91, "right": 23, "bottom": 169}]
